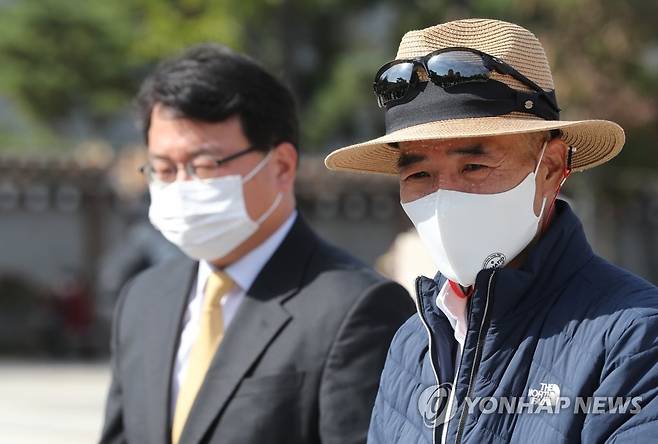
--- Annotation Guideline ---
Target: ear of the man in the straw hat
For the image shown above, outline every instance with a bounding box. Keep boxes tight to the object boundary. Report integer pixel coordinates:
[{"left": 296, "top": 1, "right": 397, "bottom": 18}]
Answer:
[{"left": 535, "top": 138, "right": 568, "bottom": 216}]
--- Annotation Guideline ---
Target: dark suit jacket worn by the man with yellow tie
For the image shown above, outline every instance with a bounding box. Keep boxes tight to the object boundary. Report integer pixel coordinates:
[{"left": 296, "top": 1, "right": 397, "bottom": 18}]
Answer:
[{"left": 101, "top": 217, "right": 415, "bottom": 444}]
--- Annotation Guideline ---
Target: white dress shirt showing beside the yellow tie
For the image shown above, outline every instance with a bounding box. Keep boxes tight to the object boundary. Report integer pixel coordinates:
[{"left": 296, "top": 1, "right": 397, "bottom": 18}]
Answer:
[{"left": 171, "top": 211, "right": 297, "bottom": 415}]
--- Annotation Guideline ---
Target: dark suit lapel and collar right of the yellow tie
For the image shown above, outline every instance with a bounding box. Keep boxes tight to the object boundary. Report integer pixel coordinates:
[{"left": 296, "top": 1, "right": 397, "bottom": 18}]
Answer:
[{"left": 181, "top": 216, "right": 317, "bottom": 442}]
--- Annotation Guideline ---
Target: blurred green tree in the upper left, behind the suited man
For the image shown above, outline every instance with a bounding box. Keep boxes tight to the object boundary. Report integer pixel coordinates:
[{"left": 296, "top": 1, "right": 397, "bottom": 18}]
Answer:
[{"left": 0, "top": 0, "right": 243, "bottom": 136}]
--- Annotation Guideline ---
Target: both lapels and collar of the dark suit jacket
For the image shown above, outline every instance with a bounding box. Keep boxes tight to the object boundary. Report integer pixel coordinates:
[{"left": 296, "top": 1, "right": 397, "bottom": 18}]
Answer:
[{"left": 145, "top": 216, "right": 319, "bottom": 442}]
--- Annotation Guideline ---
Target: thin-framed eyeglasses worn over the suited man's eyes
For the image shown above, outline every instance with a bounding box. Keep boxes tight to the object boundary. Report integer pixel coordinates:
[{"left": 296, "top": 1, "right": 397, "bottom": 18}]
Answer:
[{"left": 139, "top": 146, "right": 263, "bottom": 184}]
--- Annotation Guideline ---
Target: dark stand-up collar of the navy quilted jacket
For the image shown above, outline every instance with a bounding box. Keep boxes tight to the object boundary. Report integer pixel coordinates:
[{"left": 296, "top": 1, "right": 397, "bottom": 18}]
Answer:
[{"left": 417, "top": 200, "right": 593, "bottom": 320}]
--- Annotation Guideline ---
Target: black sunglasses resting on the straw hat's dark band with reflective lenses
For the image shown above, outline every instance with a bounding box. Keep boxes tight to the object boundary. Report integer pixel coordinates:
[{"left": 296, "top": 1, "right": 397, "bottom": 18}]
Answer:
[{"left": 373, "top": 47, "right": 559, "bottom": 111}]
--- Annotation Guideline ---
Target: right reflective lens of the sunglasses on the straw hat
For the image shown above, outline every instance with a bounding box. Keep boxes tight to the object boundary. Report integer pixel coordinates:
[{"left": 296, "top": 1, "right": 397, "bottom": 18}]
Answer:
[{"left": 427, "top": 51, "right": 491, "bottom": 88}]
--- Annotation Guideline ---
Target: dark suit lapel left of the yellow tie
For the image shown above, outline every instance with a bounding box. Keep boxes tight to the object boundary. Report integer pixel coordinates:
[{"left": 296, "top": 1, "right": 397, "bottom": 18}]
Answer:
[{"left": 144, "top": 259, "right": 198, "bottom": 443}]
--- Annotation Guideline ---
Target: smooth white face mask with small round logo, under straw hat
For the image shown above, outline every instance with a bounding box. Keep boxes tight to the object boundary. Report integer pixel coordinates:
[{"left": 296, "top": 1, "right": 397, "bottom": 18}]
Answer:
[{"left": 402, "top": 143, "right": 546, "bottom": 287}]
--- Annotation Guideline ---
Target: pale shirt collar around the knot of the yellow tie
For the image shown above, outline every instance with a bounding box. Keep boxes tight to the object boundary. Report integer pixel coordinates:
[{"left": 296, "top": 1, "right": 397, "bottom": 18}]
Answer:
[{"left": 199, "top": 210, "right": 297, "bottom": 291}]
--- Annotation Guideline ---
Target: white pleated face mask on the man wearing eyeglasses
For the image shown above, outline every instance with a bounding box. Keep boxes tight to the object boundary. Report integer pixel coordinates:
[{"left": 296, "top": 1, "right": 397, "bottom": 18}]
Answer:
[{"left": 149, "top": 152, "right": 283, "bottom": 260}]
